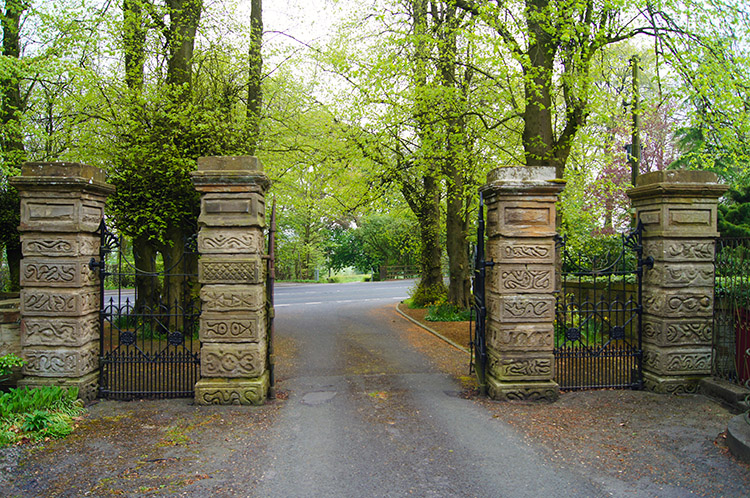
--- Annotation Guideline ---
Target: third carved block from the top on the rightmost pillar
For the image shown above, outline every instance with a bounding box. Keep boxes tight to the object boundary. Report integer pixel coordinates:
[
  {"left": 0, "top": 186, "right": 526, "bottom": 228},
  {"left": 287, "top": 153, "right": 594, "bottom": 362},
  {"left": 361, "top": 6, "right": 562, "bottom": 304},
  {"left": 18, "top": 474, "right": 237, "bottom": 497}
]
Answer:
[{"left": 643, "top": 288, "right": 714, "bottom": 318}]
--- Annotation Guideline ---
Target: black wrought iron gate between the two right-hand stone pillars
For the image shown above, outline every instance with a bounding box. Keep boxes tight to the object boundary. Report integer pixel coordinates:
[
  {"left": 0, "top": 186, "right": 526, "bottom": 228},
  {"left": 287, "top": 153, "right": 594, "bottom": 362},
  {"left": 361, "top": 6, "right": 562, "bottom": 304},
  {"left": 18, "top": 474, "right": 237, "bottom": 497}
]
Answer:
[{"left": 554, "top": 224, "right": 653, "bottom": 390}]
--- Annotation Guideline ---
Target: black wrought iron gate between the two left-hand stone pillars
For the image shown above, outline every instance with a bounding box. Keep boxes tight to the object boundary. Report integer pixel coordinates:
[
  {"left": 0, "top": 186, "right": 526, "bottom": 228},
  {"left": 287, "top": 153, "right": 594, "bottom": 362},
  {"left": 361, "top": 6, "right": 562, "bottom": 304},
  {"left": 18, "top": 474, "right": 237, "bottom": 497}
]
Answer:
[{"left": 89, "top": 221, "right": 200, "bottom": 399}]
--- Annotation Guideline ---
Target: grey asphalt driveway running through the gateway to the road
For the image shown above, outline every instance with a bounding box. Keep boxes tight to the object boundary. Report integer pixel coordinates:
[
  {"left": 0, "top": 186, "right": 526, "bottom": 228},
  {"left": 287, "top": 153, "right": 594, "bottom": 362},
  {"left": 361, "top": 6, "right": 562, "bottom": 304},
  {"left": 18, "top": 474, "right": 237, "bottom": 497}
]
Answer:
[{"left": 252, "top": 282, "right": 608, "bottom": 497}]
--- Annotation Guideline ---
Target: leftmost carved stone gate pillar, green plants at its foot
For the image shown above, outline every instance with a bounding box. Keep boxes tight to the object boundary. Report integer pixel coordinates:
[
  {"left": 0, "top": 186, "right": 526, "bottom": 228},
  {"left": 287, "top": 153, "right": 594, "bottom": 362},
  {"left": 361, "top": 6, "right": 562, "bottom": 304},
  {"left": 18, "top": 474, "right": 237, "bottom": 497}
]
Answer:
[{"left": 10, "top": 163, "right": 114, "bottom": 402}]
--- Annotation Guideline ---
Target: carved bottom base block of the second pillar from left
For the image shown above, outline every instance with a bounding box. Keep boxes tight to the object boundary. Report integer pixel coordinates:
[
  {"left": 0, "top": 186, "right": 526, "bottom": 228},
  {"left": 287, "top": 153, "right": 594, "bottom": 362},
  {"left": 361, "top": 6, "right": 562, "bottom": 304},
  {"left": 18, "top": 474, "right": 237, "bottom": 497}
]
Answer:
[{"left": 195, "top": 371, "right": 269, "bottom": 405}]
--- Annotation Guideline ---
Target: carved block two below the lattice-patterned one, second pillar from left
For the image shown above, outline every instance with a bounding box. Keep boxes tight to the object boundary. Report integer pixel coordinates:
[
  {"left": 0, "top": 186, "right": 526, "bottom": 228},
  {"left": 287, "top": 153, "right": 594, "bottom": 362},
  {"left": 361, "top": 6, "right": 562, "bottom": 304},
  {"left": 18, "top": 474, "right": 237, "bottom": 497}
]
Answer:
[{"left": 200, "top": 312, "right": 266, "bottom": 342}]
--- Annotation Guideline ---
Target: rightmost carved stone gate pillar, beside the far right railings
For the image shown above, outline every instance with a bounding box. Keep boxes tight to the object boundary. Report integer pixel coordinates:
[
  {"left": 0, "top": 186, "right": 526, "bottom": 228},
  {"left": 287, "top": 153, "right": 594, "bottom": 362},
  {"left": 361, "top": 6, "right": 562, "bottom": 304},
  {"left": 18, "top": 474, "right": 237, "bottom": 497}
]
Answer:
[{"left": 628, "top": 170, "right": 727, "bottom": 393}]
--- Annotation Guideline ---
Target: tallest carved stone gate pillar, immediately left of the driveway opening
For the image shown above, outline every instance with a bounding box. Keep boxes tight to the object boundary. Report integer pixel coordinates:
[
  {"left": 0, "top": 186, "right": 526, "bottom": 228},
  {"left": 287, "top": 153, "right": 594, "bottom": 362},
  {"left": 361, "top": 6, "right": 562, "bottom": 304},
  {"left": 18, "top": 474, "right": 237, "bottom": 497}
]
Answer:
[{"left": 192, "top": 156, "right": 269, "bottom": 405}]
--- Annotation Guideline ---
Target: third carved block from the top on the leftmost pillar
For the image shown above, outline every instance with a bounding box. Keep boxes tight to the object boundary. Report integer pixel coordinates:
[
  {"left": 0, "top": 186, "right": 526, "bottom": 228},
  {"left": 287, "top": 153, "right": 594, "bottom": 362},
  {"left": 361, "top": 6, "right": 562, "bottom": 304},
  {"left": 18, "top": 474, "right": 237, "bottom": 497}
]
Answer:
[{"left": 21, "top": 287, "right": 99, "bottom": 317}]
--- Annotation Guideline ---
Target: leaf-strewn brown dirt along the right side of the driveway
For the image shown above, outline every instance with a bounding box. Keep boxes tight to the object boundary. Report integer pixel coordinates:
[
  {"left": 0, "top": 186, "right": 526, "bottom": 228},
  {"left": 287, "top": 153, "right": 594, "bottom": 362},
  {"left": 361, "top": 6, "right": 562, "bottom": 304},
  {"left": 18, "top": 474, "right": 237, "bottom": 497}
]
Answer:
[{"left": 401, "top": 307, "right": 750, "bottom": 497}]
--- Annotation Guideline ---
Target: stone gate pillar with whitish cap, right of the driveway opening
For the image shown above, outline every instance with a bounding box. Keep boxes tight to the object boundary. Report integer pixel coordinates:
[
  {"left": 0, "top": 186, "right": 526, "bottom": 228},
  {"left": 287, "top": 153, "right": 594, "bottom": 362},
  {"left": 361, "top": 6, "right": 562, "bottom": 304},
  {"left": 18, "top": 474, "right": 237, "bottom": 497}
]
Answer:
[{"left": 480, "top": 167, "right": 564, "bottom": 400}]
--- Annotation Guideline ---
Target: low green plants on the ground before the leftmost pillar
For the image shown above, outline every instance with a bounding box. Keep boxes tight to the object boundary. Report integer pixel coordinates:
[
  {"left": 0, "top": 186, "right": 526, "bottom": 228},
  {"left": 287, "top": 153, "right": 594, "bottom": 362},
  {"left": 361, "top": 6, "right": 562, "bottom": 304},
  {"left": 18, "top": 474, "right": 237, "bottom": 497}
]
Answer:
[{"left": 0, "top": 386, "right": 84, "bottom": 447}]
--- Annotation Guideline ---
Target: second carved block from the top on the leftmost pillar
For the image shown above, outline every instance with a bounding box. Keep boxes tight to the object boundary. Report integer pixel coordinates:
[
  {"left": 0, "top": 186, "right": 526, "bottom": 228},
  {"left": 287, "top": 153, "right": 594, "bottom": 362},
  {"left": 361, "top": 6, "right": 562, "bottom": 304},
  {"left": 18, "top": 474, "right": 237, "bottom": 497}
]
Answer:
[{"left": 21, "top": 257, "right": 98, "bottom": 288}]
